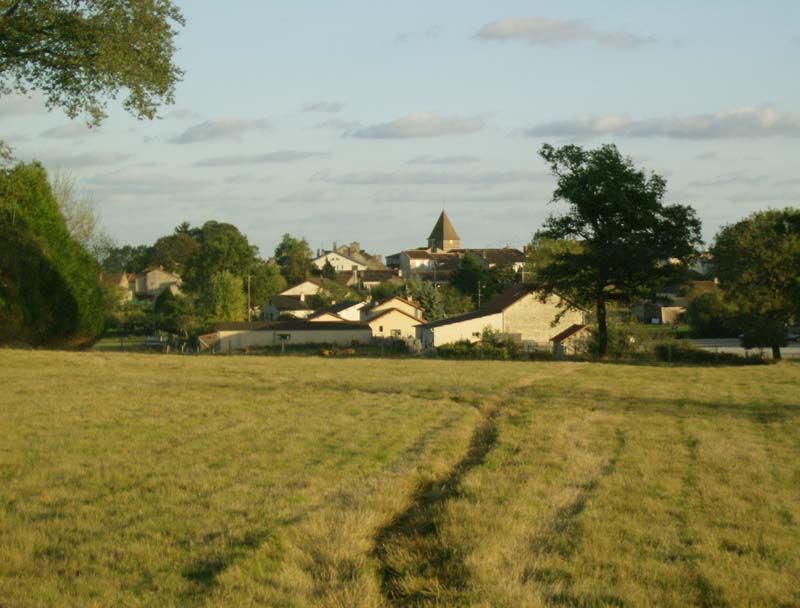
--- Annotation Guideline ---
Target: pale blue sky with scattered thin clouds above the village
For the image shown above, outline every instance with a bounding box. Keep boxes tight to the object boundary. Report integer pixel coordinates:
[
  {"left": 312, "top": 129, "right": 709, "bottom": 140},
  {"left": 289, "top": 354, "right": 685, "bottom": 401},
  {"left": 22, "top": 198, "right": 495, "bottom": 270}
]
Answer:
[{"left": 0, "top": 0, "right": 800, "bottom": 255}]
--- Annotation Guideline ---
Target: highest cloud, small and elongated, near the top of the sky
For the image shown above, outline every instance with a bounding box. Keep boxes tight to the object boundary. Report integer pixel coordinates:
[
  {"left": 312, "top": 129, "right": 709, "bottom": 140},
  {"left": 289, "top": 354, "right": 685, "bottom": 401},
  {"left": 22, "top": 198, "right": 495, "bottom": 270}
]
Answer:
[{"left": 475, "top": 17, "right": 655, "bottom": 49}]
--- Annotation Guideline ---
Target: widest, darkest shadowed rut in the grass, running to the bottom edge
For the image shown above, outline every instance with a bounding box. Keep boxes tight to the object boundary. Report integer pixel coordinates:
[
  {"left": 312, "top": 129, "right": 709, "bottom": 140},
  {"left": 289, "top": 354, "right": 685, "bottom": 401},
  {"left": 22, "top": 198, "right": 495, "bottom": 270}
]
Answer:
[{"left": 374, "top": 409, "right": 497, "bottom": 606}]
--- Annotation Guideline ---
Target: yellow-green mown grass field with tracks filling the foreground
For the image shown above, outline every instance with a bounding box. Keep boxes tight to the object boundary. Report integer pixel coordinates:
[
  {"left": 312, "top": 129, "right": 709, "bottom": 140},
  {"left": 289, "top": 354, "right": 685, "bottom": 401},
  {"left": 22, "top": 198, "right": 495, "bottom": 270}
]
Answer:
[{"left": 0, "top": 350, "right": 800, "bottom": 607}]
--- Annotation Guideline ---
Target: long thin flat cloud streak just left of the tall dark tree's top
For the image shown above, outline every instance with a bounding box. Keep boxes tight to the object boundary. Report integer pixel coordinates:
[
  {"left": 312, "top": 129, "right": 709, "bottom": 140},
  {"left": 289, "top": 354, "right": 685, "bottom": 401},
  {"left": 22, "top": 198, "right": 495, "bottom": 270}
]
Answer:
[{"left": 311, "top": 171, "right": 546, "bottom": 186}]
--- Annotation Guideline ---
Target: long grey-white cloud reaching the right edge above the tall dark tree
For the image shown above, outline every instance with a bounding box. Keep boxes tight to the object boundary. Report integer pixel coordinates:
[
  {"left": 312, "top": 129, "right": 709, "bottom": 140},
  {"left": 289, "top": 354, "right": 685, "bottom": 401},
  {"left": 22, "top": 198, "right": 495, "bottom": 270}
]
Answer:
[{"left": 525, "top": 106, "right": 800, "bottom": 139}]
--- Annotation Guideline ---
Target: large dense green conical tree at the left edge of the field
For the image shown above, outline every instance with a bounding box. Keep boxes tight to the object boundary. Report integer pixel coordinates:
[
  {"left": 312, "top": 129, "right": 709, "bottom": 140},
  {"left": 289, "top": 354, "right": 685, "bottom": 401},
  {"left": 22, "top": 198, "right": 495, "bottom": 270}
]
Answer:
[{"left": 0, "top": 163, "right": 104, "bottom": 346}]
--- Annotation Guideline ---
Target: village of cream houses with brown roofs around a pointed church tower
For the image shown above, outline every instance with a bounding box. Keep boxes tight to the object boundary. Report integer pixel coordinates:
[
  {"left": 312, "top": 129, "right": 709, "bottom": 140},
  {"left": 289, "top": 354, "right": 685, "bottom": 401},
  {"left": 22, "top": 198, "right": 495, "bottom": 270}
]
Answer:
[{"left": 97, "top": 210, "right": 716, "bottom": 355}]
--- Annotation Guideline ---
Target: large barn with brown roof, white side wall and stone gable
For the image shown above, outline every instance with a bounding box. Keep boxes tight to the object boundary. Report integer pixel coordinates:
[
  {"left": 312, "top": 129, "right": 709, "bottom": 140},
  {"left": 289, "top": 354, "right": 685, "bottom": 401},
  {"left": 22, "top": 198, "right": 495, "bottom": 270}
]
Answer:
[{"left": 417, "top": 284, "right": 583, "bottom": 348}]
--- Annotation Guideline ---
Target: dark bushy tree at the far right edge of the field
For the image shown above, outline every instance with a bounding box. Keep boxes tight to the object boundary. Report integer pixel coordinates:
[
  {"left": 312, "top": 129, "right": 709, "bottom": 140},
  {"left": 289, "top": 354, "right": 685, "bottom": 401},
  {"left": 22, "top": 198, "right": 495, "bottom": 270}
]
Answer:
[{"left": 711, "top": 208, "right": 800, "bottom": 359}]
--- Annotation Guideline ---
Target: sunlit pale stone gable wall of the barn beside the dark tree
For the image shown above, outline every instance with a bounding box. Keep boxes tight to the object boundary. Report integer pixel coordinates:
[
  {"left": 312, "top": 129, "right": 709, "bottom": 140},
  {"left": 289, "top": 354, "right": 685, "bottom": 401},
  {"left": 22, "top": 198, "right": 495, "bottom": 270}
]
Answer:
[{"left": 502, "top": 293, "right": 584, "bottom": 344}]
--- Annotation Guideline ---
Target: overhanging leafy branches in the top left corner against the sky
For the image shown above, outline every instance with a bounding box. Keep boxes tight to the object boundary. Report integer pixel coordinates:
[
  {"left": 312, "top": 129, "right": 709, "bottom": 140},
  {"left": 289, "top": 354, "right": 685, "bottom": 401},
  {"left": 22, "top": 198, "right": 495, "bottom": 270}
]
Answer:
[{"left": 0, "top": 0, "right": 184, "bottom": 124}]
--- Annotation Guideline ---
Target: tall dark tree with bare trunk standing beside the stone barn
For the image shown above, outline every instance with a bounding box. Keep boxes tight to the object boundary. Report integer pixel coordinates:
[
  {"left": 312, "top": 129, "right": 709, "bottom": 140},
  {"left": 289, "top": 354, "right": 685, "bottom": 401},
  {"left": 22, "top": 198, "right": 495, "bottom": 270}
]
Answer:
[{"left": 534, "top": 144, "right": 701, "bottom": 356}]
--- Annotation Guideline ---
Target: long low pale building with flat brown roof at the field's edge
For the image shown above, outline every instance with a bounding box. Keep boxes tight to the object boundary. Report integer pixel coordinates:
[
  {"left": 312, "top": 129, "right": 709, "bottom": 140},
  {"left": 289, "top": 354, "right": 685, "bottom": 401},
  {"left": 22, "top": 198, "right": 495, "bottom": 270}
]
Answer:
[{"left": 200, "top": 320, "right": 372, "bottom": 352}]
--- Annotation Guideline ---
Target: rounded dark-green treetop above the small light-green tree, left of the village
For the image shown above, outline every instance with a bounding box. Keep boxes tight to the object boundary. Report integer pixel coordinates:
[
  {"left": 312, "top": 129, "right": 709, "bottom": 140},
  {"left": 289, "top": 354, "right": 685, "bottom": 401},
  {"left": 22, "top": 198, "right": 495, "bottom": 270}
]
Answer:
[{"left": 182, "top": 221, "right": 258, "bottom": 293}]
